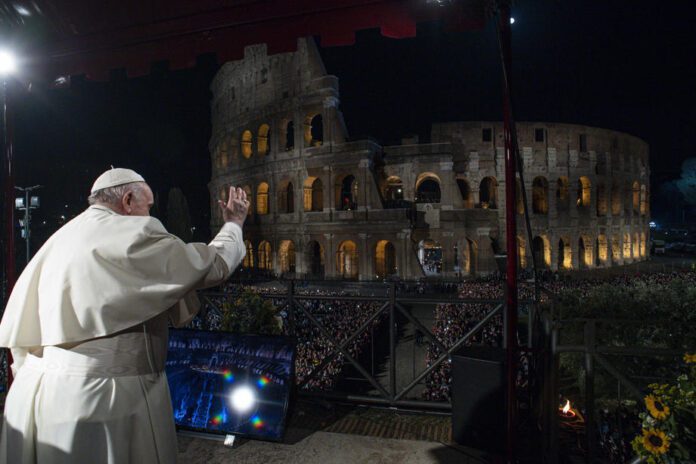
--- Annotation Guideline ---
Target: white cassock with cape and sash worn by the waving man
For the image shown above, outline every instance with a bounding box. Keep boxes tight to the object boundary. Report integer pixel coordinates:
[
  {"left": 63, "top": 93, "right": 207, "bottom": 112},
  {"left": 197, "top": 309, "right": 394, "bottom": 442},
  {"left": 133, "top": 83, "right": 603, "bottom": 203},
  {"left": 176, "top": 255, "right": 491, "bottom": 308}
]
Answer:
[{"left": 0, "top": 205, "right": 246, "bottom": 464}]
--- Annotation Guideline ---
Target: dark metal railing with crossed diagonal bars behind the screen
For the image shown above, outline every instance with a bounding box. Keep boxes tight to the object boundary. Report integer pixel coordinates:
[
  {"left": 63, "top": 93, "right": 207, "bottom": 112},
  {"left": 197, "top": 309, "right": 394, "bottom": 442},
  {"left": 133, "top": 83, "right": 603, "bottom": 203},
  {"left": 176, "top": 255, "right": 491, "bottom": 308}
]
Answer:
[{"left": 196, "top": 280, "right": 535, "bottom": 411}]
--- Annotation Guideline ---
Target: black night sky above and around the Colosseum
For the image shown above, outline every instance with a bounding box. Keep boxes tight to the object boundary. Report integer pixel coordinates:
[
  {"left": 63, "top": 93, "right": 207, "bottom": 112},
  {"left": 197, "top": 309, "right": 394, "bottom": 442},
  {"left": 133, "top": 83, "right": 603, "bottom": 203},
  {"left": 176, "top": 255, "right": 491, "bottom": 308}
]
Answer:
[{"left": 14, "top": 0, "right": 696, "bottom": 252}]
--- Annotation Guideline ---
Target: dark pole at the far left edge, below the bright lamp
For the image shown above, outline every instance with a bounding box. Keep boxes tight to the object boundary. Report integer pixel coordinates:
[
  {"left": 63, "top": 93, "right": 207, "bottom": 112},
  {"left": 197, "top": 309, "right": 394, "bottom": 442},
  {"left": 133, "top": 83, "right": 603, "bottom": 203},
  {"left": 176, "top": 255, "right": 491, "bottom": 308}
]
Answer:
[{"left": 2, "top": 80, "right": 17, "bottom": 387}]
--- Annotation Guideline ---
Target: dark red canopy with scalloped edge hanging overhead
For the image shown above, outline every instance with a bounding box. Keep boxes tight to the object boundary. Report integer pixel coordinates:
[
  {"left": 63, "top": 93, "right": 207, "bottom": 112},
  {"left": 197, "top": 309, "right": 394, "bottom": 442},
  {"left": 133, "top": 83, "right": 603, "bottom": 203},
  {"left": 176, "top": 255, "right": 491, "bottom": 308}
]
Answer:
[{"left": 0, "top": 0, "right": 485, "bottom": 79}]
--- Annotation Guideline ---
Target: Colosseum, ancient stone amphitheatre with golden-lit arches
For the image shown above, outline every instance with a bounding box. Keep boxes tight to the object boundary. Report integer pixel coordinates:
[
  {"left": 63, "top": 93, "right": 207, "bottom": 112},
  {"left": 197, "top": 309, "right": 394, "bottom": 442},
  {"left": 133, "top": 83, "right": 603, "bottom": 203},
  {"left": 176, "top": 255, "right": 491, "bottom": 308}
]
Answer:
[{"left": 209, "top": 40, "right": 650, "bottom": 280}]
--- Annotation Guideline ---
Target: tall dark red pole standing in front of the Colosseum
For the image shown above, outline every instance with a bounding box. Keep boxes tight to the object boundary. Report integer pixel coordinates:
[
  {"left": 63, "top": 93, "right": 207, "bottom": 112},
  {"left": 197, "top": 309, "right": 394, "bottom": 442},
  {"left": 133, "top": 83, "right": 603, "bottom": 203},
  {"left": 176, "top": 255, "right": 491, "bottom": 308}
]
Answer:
[{"left": 498, "top": 0, "right": 518, "bottom": 463}]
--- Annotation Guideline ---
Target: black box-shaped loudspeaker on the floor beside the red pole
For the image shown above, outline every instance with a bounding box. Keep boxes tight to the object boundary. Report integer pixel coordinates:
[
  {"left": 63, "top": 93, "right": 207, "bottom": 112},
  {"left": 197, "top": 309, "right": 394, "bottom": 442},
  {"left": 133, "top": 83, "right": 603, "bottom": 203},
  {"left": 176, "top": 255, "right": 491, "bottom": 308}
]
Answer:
[{"left": 452, "top": 346, "right": 507, "bottom": 454}]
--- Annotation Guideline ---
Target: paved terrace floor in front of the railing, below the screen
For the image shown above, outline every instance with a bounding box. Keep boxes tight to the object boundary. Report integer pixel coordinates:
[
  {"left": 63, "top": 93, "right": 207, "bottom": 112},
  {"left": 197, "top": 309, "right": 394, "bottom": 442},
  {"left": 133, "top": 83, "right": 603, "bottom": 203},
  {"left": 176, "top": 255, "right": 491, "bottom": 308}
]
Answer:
[{"left": 179, "top": 402, "right": 489, "bottom": 464}]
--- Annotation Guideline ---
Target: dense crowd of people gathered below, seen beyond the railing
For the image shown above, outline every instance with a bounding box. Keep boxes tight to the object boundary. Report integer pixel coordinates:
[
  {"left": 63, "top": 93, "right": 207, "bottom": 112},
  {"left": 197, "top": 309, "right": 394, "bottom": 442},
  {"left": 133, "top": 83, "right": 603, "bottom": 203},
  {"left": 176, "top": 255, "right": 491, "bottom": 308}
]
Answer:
[{"left": 192, "top": 272, "right": 696, "bottom": 401}]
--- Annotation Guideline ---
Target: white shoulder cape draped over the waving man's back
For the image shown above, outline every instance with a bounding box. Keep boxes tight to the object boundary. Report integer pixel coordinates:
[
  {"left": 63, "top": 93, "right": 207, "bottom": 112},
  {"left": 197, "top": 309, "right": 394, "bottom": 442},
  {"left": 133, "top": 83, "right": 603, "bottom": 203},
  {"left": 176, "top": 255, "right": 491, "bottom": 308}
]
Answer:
[{"left": 0, "top": 206, "right": 216, "bottom": 348}]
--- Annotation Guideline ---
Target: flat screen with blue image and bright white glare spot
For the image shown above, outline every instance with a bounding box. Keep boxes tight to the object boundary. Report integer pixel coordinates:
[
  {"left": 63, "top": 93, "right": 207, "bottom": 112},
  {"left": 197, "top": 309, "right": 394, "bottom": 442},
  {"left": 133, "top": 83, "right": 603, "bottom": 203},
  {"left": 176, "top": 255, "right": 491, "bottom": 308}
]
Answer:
[{"left": 166, "top": 329, "right": 295, "bottom": 441}]
